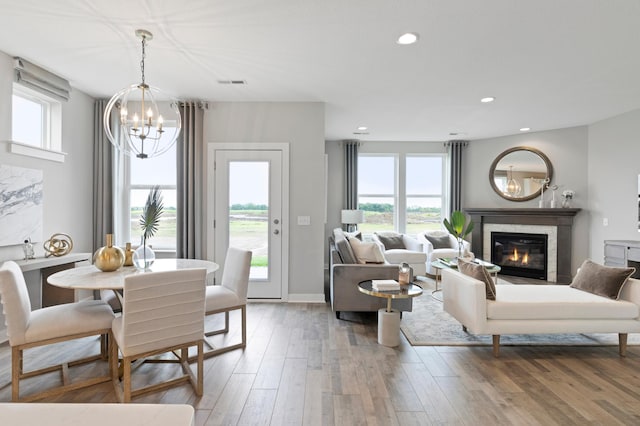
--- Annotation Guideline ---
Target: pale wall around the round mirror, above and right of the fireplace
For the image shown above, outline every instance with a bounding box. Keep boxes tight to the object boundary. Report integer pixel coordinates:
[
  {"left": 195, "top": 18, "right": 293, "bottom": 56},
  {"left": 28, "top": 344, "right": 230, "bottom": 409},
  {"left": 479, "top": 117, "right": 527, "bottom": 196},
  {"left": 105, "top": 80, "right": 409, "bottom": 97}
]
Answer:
[{"left": 462, "top": 126, "right": 590, "bottom": 273}]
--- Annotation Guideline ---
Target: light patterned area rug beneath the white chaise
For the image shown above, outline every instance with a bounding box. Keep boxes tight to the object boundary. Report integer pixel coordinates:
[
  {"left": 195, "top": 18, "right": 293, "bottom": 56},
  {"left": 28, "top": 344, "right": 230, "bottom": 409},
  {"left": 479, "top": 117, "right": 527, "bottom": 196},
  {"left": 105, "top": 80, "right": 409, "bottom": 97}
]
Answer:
[{"left": 400, "top": 279, "right": 640, "bottom": 346}]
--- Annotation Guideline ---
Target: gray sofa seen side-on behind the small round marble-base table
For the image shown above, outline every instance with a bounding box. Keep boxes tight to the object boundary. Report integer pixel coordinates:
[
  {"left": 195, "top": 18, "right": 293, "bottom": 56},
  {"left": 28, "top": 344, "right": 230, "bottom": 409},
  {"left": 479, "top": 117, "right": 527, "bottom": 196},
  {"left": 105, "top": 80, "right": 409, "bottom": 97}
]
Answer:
[{"left": 329, "top": 228, "right": 413, "bottom": 319}]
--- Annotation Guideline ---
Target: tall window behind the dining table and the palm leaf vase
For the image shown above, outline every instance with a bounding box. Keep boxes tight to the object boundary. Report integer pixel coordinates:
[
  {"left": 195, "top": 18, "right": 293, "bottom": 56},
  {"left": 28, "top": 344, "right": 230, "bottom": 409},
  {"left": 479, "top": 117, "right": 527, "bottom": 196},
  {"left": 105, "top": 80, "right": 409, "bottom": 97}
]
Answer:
[{"left": 114, "top": 125, "right": 178, "bottom": 251}]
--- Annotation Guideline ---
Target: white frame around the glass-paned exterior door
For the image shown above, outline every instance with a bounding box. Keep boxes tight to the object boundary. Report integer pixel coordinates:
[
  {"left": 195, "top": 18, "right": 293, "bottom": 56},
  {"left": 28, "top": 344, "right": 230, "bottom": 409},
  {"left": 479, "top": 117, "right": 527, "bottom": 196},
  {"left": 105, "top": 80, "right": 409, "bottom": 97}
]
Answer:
[{"left": 205, "top": 142, "right": 290, "bottom": 302}]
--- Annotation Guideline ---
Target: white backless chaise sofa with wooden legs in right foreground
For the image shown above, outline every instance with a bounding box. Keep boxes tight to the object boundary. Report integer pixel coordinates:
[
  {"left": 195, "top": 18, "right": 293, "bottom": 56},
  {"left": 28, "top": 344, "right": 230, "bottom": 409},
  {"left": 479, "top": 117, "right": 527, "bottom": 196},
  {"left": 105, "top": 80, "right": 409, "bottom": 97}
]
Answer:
[{"left": 442, "top": 269, "right": 640, "bottom": 357}]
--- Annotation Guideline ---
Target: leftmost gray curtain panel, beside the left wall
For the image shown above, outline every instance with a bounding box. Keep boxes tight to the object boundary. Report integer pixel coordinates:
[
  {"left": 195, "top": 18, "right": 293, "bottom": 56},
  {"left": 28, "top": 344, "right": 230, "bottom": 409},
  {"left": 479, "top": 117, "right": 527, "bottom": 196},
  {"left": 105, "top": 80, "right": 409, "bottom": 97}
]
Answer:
[{"left": 93, "top": 99, "right": 114, "bottom": 252}]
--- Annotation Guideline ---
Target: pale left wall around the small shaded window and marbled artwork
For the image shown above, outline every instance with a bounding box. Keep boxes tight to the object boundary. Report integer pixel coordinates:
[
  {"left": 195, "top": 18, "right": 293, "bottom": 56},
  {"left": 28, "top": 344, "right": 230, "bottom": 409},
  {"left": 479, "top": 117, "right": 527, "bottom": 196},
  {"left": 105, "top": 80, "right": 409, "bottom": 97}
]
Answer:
[{"left": 0, "top": 53, "right": 93, "bottom": 261}]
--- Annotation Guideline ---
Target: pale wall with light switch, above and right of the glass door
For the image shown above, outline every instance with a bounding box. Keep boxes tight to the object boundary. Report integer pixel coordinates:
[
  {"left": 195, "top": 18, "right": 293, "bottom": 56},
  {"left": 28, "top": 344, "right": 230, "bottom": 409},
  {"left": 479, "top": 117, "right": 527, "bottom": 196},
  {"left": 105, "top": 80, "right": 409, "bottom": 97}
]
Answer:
[{"left": 204, "top": 102, "right": 325, "bottom": 301}]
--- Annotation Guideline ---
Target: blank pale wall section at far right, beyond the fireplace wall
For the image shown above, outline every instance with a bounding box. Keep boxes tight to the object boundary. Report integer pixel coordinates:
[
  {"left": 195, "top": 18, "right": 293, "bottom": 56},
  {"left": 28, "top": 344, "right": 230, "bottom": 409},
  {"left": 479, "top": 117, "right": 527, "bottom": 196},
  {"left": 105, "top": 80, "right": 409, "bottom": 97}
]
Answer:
[{"left": 587, "top": 110, "right": 640, "bottom": 262}]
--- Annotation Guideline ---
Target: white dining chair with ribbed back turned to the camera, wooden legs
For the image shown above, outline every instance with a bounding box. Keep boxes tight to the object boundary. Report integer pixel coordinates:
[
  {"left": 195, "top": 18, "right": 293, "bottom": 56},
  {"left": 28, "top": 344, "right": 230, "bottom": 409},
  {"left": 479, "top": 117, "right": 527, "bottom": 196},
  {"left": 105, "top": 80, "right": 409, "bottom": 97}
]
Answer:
[{"left": 110, "top": 268, "right": 206, "bottom": 402}]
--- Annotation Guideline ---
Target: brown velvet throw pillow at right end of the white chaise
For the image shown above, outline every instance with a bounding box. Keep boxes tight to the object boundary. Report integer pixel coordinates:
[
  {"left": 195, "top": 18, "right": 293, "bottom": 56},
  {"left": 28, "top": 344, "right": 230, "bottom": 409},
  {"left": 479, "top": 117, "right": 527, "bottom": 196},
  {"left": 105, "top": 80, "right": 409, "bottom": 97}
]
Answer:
[{"left": 569, "top": 259, "right": 636, "bottom": 300}]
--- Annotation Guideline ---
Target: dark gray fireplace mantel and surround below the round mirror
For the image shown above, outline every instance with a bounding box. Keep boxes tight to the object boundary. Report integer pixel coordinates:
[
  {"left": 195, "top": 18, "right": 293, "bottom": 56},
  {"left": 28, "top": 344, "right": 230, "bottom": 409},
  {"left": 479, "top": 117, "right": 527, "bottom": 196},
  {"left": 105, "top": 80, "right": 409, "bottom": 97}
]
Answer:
[{"left": 464, "top": 208, "right": 581, "bottom": 283}]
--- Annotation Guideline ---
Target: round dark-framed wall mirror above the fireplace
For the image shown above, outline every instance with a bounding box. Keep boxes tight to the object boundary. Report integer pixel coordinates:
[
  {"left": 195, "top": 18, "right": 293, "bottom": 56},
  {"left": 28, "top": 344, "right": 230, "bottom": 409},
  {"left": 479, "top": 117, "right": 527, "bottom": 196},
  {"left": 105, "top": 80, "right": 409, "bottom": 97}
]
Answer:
[{"left": 489, "top": 146, "right": 553, "bottom": 201}]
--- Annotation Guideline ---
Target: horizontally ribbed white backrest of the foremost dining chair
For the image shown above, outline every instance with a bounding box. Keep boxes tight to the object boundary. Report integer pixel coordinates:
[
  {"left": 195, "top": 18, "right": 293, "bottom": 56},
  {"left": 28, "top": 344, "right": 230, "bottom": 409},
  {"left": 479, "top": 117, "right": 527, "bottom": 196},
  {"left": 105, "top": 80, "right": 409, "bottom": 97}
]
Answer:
[{"left": 120, "top": 269, "right": 206, "bottom": 355}]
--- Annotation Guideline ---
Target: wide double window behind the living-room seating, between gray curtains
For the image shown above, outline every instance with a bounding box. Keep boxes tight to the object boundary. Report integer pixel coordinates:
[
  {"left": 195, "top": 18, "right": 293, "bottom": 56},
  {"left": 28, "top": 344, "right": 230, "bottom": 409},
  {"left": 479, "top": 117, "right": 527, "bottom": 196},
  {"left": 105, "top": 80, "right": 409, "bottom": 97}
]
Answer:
[{"left": 358, "top": 154, "right": 445, "bottom": 235}]
